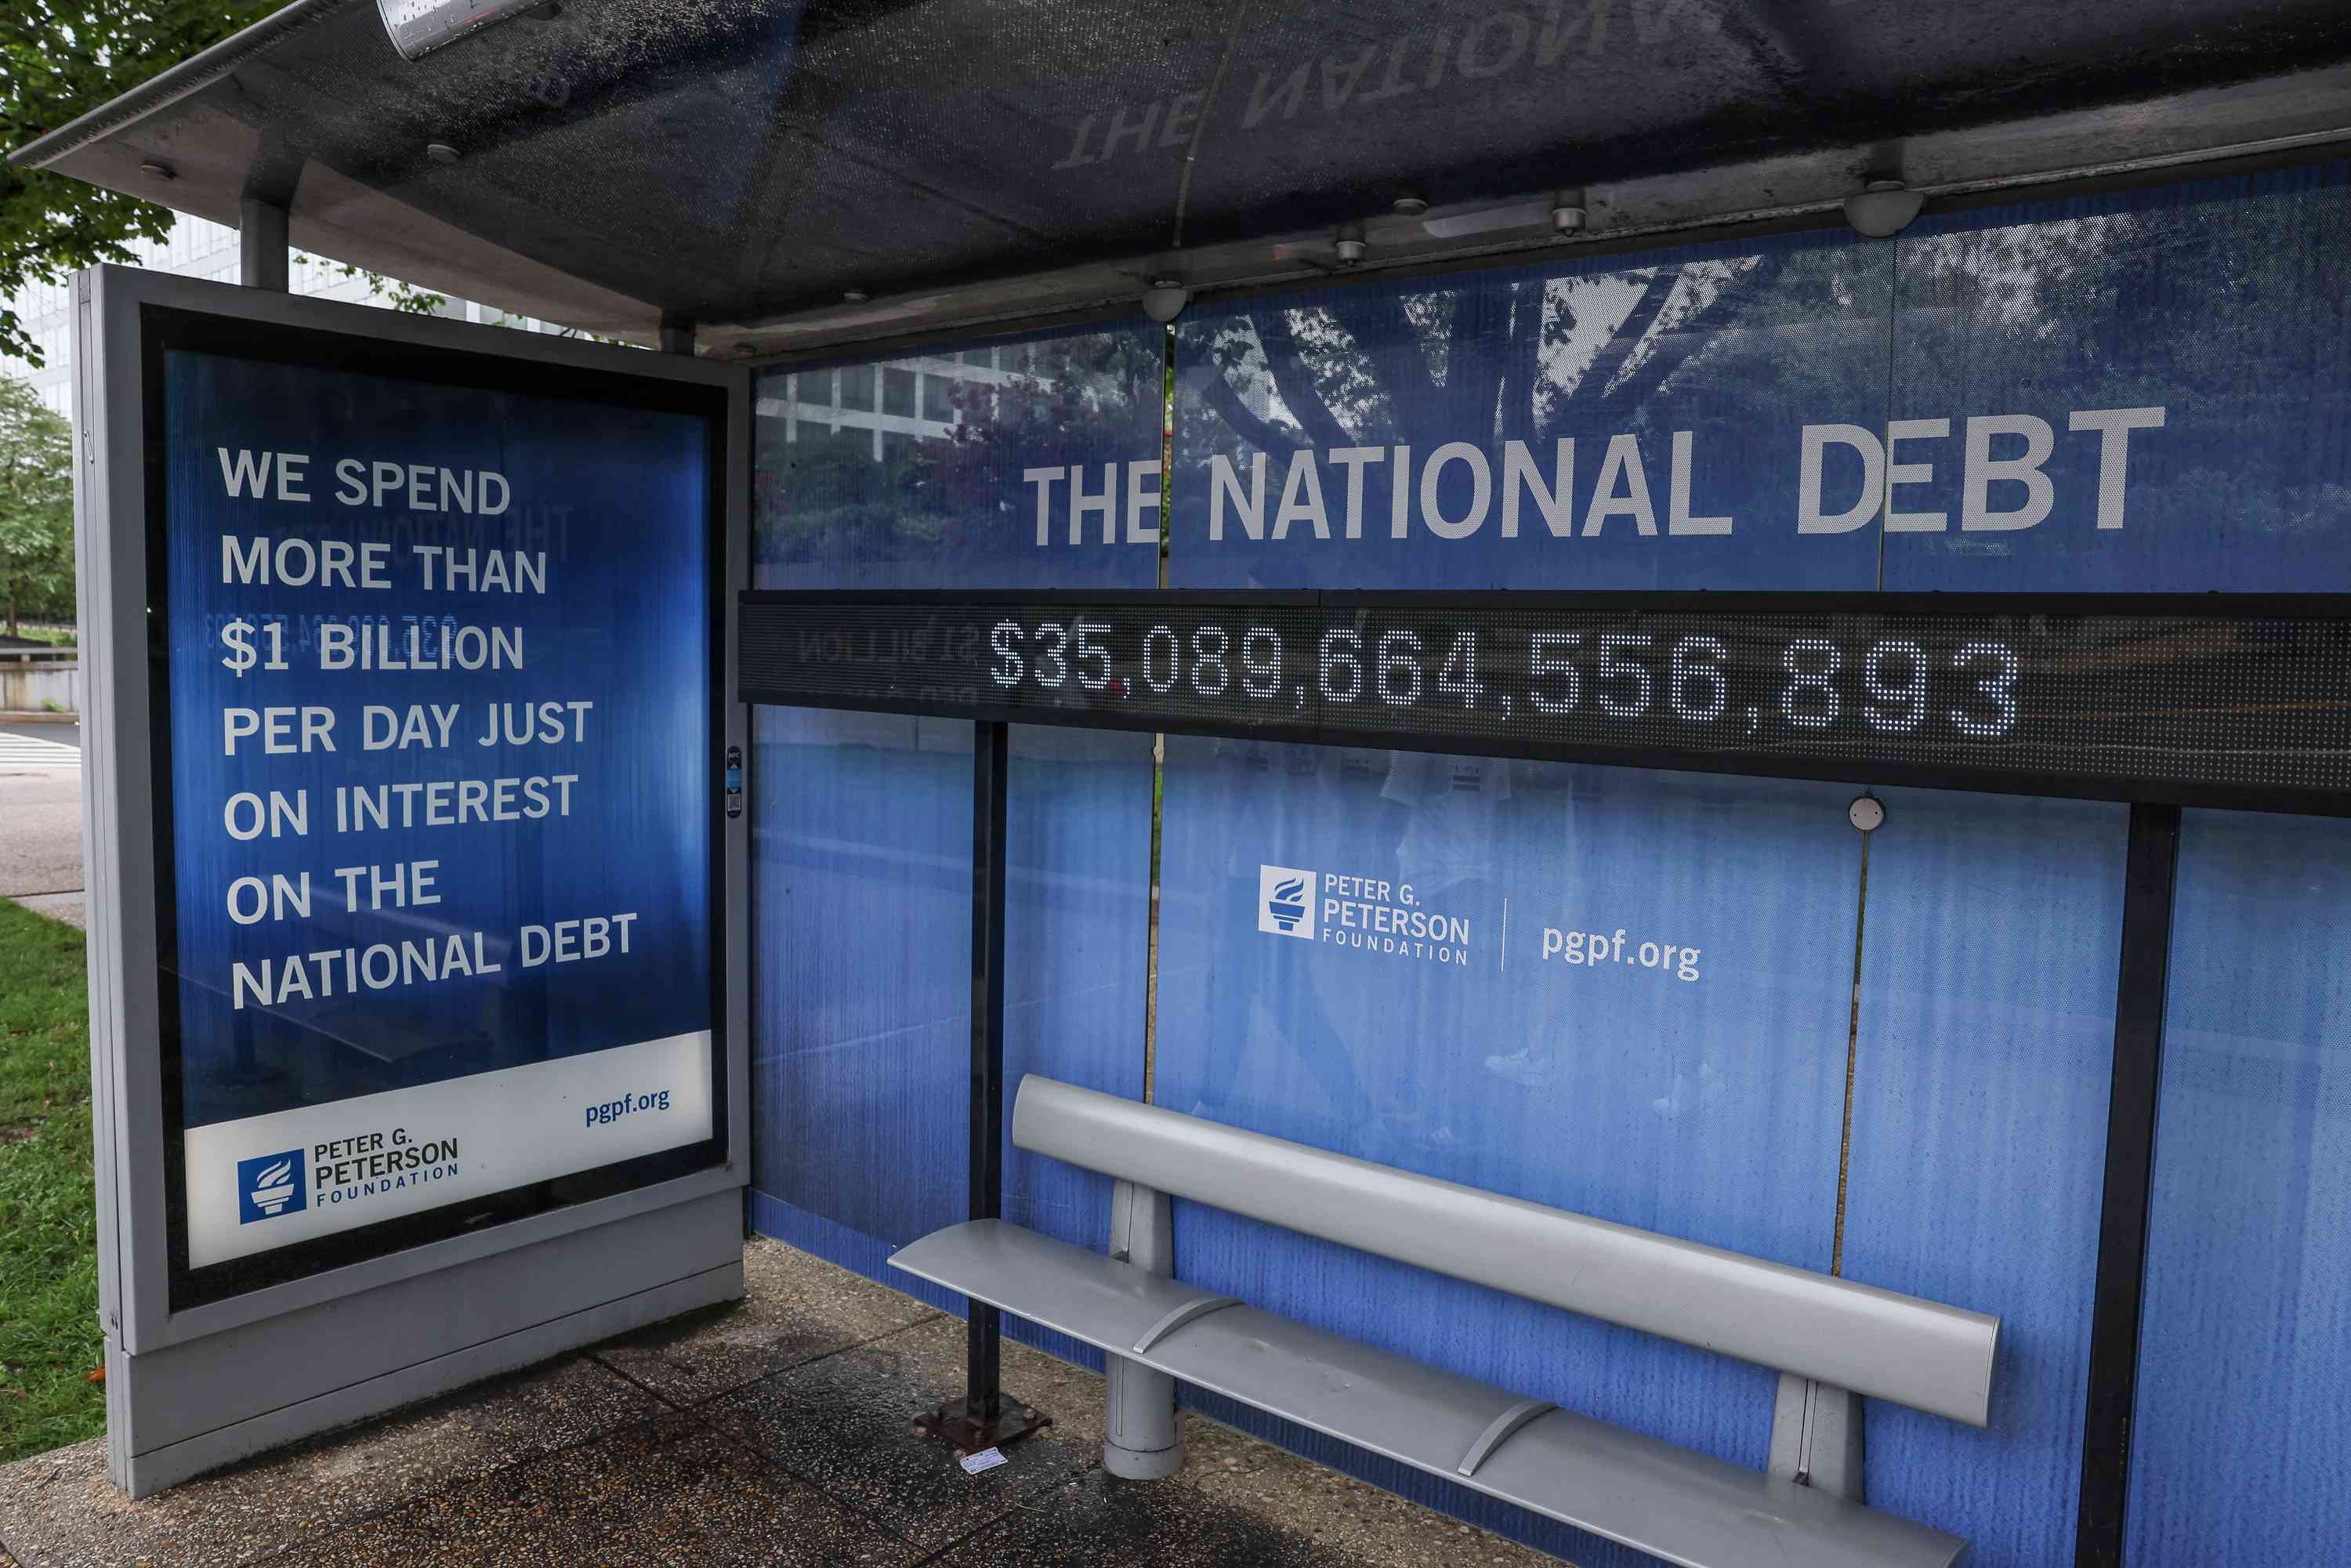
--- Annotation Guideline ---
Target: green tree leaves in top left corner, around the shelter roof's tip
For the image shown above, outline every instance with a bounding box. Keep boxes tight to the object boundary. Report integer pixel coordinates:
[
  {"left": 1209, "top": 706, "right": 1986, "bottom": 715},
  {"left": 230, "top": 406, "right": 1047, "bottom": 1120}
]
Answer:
[{"left": 0, "top": 0, "right": 444, "bottom": 364}]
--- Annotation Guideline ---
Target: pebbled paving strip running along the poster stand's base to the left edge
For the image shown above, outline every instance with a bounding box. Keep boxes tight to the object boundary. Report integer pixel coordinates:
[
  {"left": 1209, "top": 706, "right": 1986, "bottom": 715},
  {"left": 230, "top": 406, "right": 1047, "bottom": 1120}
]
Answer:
[{"left": 0, "top": 1356, "right": 663, "bottom": 1568}]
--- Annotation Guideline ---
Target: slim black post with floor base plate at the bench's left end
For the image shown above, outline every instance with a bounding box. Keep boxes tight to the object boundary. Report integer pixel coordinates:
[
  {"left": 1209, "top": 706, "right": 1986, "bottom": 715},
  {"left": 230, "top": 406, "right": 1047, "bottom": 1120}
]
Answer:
[{"left": 919, "top": 722, "right": 1053, "bottom": 1453}]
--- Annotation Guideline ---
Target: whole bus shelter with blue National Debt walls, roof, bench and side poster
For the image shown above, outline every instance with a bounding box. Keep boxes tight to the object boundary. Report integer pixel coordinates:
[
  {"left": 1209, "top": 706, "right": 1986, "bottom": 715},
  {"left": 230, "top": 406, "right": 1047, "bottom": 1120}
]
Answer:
[{"left": 14, "top": 0, "right": 2351, "bottom": 1566}]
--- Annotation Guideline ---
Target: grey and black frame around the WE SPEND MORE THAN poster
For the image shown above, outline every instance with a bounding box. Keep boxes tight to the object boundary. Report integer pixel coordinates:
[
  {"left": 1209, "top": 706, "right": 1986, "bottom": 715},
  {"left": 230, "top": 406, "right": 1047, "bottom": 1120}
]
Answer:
[{"left": 75, "top": 266, "right": 750, "bottom": 1354}]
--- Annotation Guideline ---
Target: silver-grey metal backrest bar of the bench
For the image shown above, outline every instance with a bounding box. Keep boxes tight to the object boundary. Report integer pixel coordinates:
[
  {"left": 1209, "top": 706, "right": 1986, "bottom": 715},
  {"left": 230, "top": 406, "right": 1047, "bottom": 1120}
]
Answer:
[{"left": 1013, "top": 1074, "right": 2001, "bottom": 1427}]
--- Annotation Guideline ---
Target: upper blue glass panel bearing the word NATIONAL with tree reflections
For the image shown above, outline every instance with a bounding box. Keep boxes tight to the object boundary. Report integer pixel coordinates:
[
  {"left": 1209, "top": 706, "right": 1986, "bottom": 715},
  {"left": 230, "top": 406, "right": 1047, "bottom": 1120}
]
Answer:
[{"left": 1173, "top": 222, "right": 1893, "bottom": 590}]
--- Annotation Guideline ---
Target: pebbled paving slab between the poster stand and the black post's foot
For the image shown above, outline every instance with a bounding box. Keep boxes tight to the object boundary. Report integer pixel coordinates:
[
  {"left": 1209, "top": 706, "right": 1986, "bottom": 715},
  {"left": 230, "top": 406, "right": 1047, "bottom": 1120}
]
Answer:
[{"left": 595, "top": 1239, "right": 940, "bottom": 1406}]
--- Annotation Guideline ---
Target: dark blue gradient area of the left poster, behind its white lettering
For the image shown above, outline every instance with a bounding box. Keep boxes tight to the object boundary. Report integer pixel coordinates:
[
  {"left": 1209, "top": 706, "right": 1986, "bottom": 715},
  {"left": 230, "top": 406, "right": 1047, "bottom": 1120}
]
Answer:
[{"left": 165, "top": 350, "right": 712, "bottom": 1126}]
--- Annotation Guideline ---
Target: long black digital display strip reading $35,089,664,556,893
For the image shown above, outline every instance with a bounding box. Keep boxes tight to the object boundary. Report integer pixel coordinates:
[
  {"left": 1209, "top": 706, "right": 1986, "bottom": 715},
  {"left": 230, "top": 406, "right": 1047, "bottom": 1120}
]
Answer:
[{"left": 741, "top": 592, "right": 2351, "bottom": 813}]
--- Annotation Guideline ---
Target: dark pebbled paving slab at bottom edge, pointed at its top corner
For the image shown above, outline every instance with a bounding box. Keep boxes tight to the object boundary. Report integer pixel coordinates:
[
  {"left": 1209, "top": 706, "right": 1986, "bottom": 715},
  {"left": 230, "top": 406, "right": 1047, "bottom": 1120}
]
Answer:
[{"left": 301, "top": 1413, "right": 917, "bottom": 1568}]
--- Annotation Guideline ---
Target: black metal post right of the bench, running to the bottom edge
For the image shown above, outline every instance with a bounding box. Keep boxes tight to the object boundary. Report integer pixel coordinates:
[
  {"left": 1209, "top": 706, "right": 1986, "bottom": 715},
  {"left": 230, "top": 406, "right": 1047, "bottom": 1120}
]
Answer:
[{"left": 2074, "top": 806, "right": 2179, "bottom": 1568}]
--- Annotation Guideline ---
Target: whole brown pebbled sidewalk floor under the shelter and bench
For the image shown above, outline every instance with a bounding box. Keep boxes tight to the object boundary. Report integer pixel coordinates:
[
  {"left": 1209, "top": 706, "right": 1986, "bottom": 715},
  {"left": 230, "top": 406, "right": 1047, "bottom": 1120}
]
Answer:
[{"left": 0, "top": 1241, "right": 1559, "bottom": 1568}]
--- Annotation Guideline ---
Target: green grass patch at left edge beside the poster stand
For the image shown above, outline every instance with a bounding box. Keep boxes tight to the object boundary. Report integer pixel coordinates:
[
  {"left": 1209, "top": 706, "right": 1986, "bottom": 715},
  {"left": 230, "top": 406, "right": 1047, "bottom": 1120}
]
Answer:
[{"left": 0, "top": 898, "right": 106, "bottom": 1462}]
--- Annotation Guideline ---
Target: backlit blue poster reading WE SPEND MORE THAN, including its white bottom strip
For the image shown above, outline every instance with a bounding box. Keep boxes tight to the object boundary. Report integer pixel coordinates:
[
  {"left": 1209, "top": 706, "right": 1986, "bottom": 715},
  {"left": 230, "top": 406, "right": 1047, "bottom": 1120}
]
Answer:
[{"left": 148, "top": 327, "right": 724, "bottom": 1300}]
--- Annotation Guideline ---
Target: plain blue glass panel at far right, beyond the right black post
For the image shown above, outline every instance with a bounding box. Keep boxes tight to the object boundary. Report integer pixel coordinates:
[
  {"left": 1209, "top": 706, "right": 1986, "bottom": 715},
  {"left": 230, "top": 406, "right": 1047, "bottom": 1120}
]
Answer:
[{"left": 2125, "top": 811, "right": 2351, "bottom": 1568}]
